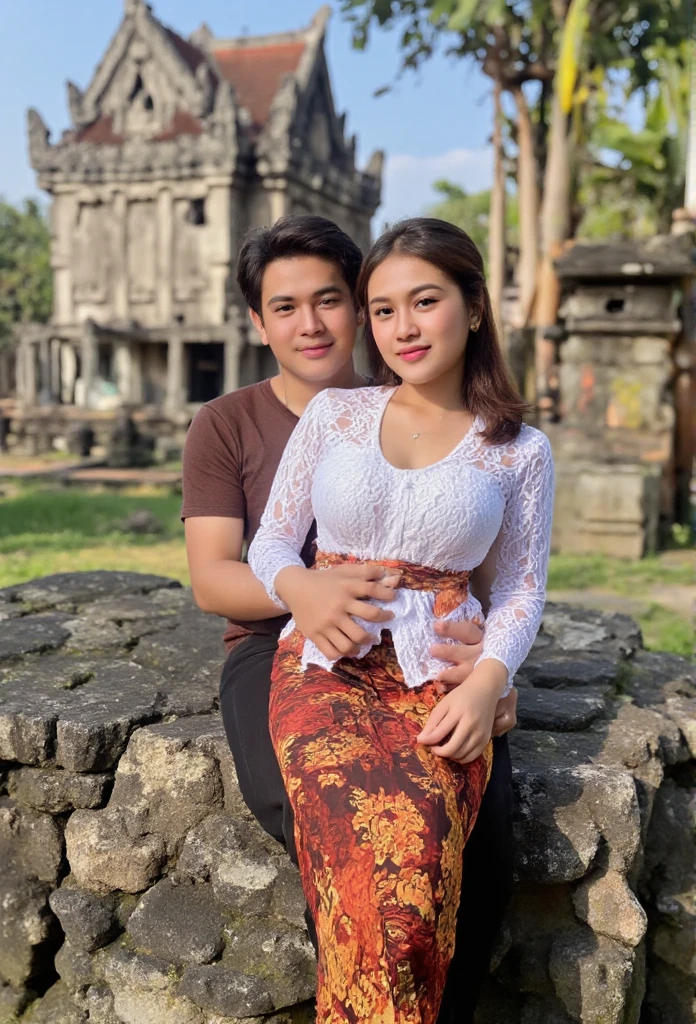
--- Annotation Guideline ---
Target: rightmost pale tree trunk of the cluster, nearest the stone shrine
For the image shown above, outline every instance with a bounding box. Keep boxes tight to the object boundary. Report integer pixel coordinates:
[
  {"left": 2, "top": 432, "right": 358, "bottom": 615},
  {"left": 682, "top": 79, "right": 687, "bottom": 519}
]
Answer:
[{"left": 534, "top": 89, "right": 571, "bottom": 412}]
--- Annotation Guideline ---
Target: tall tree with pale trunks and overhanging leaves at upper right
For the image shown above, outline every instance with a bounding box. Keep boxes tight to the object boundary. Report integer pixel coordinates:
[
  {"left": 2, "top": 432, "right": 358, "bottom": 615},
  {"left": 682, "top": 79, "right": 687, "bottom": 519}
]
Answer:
[{"left": 340, "top": 0, "right": 689, "bottom": 403}]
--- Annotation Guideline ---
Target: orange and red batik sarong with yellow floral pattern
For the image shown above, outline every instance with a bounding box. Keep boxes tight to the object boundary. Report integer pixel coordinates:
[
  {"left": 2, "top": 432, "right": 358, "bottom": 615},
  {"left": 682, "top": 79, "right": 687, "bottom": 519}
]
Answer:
[{"left": 269, "top": 555, "right": 492, "bottom": 1024}]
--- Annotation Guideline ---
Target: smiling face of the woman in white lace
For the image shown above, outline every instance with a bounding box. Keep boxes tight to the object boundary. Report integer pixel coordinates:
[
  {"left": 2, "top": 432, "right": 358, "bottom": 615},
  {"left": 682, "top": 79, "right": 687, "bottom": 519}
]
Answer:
[{"left": 367, "top": 254, "right": 471, "bottom": 385}]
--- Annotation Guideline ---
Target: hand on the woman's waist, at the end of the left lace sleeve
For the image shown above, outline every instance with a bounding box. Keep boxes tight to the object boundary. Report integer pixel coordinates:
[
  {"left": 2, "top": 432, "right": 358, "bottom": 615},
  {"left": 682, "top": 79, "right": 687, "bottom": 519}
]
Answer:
[{"left": 275, "top": 562, "right": 399, "bottom": 662}]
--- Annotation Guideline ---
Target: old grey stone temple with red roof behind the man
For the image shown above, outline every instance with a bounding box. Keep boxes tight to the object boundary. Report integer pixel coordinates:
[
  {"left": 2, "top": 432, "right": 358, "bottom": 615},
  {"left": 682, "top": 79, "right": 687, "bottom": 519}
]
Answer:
[{"left": 13, "top": 0, "right": 383, "bottom": 446}]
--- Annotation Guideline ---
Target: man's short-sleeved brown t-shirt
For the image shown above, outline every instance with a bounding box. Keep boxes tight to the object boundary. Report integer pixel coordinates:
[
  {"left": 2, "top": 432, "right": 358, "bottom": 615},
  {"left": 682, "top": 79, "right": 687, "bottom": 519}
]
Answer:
[{"left": 181, "top": 380, "right": 314, "bottom": 647}]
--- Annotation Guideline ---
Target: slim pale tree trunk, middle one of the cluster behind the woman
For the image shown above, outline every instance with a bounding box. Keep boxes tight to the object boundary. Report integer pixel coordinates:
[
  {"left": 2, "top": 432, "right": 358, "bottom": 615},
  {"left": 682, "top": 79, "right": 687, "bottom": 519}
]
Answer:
[{"left": 513, "top": 86, "right": 538, "bottom": 326}]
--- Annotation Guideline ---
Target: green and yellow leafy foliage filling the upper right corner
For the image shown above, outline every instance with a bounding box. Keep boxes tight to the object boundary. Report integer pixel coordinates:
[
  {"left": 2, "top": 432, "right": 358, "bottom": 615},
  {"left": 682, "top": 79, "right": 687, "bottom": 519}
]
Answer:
[{"left": 339, "top": 0, "right": 690, "bottom": 245}]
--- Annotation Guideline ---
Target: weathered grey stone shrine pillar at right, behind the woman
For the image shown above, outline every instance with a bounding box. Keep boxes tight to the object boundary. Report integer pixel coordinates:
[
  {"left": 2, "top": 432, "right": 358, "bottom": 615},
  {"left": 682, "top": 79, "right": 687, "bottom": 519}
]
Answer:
[{"left": 545, "top": 233, "right": 695, "bottom": 558}]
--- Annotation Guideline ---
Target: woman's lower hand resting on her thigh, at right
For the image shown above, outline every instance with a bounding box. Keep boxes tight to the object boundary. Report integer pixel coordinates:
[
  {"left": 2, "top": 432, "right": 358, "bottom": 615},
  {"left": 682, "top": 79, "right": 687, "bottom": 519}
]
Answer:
[{"left": 418, "top": 658, "right": 508, "bottom": 764}]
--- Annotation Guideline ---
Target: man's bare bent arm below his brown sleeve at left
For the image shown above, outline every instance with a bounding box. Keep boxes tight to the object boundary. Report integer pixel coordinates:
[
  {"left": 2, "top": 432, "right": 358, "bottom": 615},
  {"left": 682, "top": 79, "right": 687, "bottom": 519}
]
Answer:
[{"left": 184, "top": 516, "right": 284, "bottom": 622}]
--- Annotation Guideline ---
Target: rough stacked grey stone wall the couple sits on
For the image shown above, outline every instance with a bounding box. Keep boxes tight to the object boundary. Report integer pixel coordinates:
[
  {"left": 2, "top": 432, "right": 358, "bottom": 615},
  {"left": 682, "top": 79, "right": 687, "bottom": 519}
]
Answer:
[{"left": 0, "top": 572, "right": 696, "bottom": 1024}]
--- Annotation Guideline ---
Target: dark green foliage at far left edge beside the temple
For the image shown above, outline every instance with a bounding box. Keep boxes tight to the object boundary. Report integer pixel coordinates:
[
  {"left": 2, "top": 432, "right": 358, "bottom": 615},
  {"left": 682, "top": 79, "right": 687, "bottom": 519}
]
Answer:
[{"left": 0, "top": 200, "right": 53, "bottom": 347}]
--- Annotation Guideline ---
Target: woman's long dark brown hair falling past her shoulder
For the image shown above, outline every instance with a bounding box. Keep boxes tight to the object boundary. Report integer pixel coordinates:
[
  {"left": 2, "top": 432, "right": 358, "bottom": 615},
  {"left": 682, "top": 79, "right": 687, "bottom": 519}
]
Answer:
[{"left": 356, "top": 217, "right": 527, "bottom": 444}]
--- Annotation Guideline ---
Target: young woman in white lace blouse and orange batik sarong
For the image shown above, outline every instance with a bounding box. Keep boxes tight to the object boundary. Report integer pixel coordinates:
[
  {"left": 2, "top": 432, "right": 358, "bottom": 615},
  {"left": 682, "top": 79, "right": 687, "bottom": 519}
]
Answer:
[{"left": 249, "top": 218, "right": 553, "bottom": 1024}]
